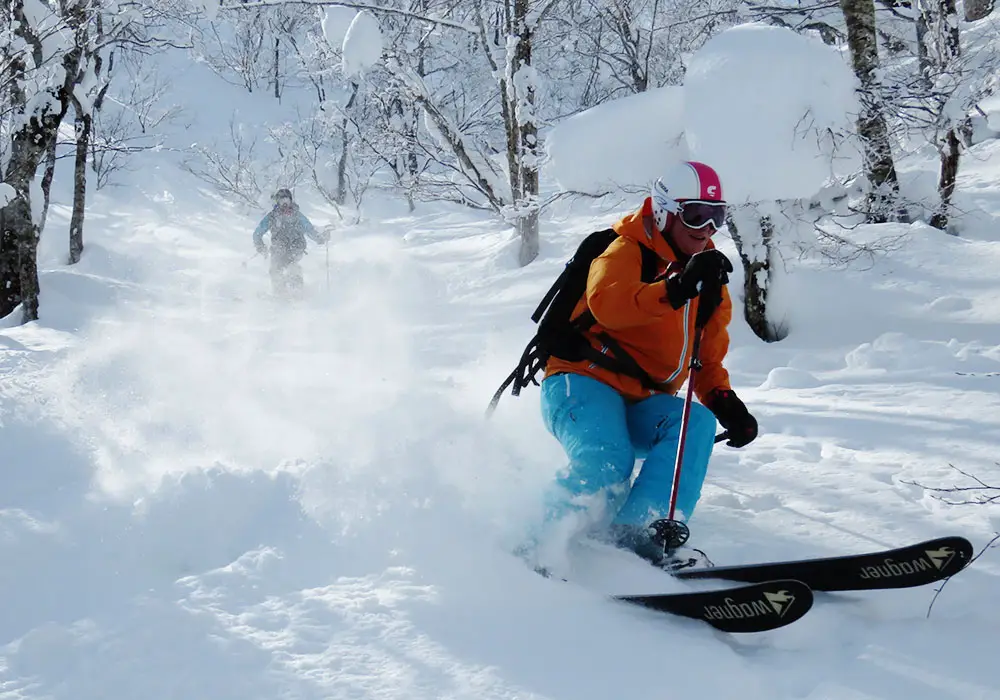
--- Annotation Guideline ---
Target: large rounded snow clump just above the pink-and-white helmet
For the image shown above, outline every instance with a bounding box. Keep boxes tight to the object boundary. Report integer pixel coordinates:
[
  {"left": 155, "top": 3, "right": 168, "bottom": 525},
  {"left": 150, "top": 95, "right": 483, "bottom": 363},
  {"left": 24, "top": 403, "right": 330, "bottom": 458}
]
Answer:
[{"left": 684, "top": 24, "right": 860, "bottom": 202}]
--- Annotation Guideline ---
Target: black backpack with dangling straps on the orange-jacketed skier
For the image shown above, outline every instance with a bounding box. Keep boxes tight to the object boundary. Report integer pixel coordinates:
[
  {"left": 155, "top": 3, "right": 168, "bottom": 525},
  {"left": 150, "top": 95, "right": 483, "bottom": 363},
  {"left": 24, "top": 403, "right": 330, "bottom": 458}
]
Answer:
[{"left": 486, "top": 228, "right": 660, "bottom": 416}]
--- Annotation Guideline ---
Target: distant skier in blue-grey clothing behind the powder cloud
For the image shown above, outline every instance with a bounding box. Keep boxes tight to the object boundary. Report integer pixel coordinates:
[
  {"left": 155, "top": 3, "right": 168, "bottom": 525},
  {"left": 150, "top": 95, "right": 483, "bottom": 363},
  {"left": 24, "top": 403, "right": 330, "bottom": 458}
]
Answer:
[{"left": 253, "top": 187, "right": 330, "bottom": 297}]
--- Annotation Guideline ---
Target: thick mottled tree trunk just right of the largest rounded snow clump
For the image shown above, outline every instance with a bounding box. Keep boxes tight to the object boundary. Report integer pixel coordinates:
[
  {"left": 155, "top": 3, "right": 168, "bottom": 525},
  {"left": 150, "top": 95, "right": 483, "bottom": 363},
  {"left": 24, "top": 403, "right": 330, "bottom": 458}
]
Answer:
[{"left": 840, "top": 0, "right": 904, "bottom": 223}]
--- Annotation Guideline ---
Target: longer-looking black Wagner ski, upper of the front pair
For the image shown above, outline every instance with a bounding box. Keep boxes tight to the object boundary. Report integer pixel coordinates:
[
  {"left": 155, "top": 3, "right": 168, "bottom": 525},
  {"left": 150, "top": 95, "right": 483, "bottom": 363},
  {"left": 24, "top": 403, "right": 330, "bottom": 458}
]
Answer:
[{"left": 674, "top": 537, "right": 972, "bottom": 591}]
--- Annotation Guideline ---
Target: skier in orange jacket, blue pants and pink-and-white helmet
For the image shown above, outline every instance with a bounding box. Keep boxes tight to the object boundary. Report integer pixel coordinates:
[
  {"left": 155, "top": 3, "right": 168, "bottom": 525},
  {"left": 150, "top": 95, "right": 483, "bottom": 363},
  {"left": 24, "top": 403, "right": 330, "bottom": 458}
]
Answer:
[{"left": 525, "top": 162, "right": 757, "bottom": 568}]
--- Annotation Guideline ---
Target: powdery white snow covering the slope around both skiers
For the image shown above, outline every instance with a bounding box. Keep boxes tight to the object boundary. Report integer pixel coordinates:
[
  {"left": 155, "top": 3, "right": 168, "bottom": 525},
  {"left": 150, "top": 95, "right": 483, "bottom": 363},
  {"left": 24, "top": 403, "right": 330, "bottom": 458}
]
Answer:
[{"left": 0, "top": 26, "right": 1000, "bottom": 700}]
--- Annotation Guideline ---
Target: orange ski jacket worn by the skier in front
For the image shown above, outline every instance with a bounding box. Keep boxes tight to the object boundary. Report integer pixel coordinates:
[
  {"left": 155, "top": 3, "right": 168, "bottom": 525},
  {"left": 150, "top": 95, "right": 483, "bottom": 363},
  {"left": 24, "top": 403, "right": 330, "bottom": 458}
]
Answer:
[{"left": 545, "top": 197, "right": 733, "bottom": 403}]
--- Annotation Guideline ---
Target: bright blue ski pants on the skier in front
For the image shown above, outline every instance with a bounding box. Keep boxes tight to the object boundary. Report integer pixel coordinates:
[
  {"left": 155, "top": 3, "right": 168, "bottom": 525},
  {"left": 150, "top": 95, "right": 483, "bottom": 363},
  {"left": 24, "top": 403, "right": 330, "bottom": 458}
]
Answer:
[{"left": 541, "top": 374, "right": 716, "bottom": 527}]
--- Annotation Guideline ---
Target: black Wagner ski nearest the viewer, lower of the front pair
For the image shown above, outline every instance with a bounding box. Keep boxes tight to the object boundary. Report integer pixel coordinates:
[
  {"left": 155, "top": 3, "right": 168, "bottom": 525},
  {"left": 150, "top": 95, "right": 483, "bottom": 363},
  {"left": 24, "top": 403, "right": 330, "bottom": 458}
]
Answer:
[{"left": 614, "top": 580, "right": 813, "bottom": 632}]
